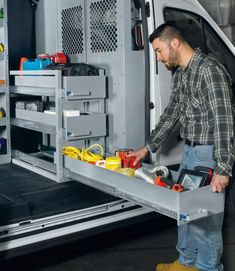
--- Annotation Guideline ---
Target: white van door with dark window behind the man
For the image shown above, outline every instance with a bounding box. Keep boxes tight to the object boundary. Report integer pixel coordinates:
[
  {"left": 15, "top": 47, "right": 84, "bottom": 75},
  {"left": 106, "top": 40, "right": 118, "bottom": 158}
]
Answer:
[{"left": 149, "top": 0, "right": 235, "bottom": 165}]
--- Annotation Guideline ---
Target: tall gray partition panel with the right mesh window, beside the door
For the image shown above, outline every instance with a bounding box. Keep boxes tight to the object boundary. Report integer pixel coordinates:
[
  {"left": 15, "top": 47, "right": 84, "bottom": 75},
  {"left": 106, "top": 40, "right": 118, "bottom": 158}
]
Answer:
[{"left": 85, "top": 0, "right": 145, "bottom": 153}]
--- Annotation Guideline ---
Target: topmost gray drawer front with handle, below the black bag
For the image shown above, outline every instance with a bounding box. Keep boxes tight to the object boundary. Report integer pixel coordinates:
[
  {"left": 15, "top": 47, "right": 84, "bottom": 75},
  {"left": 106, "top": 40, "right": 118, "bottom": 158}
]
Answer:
[{"left": 63, "top": 76, "right": 107, "bottom": 100}]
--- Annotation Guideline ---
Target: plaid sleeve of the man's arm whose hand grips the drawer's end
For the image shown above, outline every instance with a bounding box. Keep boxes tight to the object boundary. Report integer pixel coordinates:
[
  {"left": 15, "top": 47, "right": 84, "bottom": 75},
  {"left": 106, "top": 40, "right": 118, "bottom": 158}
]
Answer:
[{"left": 204, "top": 65, "right": 234, "bottom": 176}]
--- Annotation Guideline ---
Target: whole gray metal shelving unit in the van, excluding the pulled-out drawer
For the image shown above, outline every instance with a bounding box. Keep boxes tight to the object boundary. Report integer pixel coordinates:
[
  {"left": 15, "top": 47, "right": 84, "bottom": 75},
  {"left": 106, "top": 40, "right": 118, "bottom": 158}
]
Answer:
[{"left": 10, "top": 70, "right": 106, "bottom": 182}]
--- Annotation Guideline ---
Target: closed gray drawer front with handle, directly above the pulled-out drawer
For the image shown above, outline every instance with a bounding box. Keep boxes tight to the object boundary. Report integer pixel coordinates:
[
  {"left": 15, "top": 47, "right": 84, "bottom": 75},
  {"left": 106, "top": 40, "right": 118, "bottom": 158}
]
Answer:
[{"left": 64, "top": 113, "right": 106, "bottom": 140}]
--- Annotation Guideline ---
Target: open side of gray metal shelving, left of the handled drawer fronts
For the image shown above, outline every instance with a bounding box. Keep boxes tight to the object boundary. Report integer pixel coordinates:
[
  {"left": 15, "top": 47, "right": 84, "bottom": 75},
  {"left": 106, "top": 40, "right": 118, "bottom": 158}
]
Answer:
[{"left": 10, "top": 71, "right": 63, "bottom": 182}]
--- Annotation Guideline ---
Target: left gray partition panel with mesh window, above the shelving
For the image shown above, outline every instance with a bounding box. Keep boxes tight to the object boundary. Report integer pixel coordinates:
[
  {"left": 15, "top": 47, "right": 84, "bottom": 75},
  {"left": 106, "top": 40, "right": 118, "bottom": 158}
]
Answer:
[{"left": 58, "top": 0, "right": 86, "bottom": 63}]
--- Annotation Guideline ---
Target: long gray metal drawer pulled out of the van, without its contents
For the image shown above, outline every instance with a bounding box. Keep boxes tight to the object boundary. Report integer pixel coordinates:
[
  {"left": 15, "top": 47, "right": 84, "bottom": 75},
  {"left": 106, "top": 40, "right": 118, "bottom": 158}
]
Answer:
[{"left": 65, "top": 157, "right": 224, "bottom": 225}]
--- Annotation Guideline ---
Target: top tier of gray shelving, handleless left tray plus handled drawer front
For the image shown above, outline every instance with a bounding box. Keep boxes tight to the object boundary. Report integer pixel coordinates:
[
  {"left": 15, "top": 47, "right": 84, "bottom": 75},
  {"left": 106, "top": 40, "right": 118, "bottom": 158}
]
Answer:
[{"left": 10, "top": 70, "right": 107, "bottom": 100}]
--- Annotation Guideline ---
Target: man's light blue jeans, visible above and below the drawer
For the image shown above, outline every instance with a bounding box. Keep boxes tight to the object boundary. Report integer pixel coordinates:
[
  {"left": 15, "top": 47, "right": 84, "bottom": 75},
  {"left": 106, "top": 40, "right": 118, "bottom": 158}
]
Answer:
[{"left": 176, "top": 145, "right": 224, "bottom": 271}]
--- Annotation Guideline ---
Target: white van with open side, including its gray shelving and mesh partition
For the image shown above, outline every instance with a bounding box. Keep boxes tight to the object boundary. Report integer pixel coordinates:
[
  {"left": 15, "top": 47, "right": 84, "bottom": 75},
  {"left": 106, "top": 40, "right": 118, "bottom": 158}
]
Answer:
[{"left": 0, "top": 0, "right": 235, "bottom": 257}]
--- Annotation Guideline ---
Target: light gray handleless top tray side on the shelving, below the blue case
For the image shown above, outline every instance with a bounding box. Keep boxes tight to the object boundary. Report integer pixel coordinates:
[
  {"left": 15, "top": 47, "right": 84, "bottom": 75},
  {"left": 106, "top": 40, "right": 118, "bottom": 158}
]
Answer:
[{"left": 15, "top": 75, "right": 56, "bottom": 88}]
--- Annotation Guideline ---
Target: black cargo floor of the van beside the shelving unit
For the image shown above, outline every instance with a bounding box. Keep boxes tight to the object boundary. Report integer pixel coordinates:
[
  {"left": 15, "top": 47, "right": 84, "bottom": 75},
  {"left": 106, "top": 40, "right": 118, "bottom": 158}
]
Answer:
[{"left": 0, "top": 164, "right": 117, "bottom": 226}]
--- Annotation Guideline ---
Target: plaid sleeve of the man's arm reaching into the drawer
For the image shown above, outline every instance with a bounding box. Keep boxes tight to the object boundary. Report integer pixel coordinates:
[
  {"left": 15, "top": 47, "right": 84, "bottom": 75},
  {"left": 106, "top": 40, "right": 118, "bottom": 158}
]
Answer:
[{"left": 146, "top": 85, "right": 180, "bottom": 152}]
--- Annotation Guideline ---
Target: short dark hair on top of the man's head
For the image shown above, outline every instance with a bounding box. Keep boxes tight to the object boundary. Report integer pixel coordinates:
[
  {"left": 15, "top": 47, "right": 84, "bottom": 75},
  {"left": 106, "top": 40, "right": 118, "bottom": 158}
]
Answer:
[{"left": 149, "top": 24, "right": 186, "bottom": 43}]
